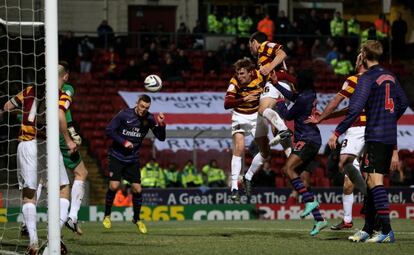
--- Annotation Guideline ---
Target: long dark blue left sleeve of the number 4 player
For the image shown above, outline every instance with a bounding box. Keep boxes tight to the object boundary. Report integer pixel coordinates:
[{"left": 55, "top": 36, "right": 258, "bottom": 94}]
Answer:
[{"left": 335, "top": 75, "right": 371, "bottom": 136}]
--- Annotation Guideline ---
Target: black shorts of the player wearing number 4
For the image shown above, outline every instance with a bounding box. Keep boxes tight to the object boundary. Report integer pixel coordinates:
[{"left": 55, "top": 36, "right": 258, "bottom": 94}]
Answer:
[{"left": 361, "top": 142, "right": 394, "bottom": 175}]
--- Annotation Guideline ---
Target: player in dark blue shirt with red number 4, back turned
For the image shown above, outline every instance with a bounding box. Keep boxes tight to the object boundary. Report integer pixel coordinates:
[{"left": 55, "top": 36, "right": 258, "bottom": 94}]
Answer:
[{"left": 329, "top": 40, "right": 408, "bottom": 243}]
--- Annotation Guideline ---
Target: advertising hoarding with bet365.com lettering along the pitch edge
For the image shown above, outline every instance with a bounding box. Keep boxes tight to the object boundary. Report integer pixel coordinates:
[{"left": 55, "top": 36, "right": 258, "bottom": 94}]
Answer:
[{"left": 0, "top": 187, "right": 414, "bottom": 222}]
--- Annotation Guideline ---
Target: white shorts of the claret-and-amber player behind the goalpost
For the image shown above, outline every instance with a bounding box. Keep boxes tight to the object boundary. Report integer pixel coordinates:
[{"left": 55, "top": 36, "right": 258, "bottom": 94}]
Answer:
[{"left": 17, "top": 140, "right": 69, "bottom": 190}]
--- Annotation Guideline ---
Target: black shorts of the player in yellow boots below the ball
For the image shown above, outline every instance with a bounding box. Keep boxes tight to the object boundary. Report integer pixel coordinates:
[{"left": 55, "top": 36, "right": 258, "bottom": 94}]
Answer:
[{"left": 108, "top": 155, "right": 141, "bottom": 183}]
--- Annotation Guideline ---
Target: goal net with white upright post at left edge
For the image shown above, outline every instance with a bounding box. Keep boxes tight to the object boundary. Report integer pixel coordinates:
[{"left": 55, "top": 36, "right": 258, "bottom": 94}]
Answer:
[{"left": 0, "top": 0, "right": 60, "bottom": 254}]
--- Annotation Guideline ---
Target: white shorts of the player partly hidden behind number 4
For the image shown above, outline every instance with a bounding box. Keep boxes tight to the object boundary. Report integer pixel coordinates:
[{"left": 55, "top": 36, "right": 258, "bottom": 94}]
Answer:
[{"left": 340, "top": 126, "right": 365, "bottom": 157}]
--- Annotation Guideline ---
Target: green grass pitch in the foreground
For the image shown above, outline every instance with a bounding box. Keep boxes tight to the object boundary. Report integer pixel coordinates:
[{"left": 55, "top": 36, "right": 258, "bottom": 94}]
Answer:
[{"left": 0, "top": 220, "right": 414, "bottom": 255}]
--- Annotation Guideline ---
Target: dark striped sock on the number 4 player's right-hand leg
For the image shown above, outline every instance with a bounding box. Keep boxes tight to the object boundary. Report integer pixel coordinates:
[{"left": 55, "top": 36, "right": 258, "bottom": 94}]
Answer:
[{"left": 371, "top": 185, "right": 391, "bottom": 235}]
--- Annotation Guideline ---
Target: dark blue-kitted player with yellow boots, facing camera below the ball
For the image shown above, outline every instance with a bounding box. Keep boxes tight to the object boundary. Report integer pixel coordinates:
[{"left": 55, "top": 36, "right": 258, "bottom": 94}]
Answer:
[{"left": 102, "top": 95, "right": 165, "bottom": 234}]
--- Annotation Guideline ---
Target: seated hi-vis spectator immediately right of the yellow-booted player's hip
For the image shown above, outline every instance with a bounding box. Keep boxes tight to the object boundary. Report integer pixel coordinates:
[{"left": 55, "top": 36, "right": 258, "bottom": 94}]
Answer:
[{"left": 141, "top": 158, "right": 165, "bottom": 188}]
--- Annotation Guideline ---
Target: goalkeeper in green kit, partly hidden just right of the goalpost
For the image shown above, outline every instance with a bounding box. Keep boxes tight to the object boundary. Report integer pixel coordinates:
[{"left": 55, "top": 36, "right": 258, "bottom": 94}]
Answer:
[{"left": 59, "top": 61, "right": 88, "bottom": 235}]
